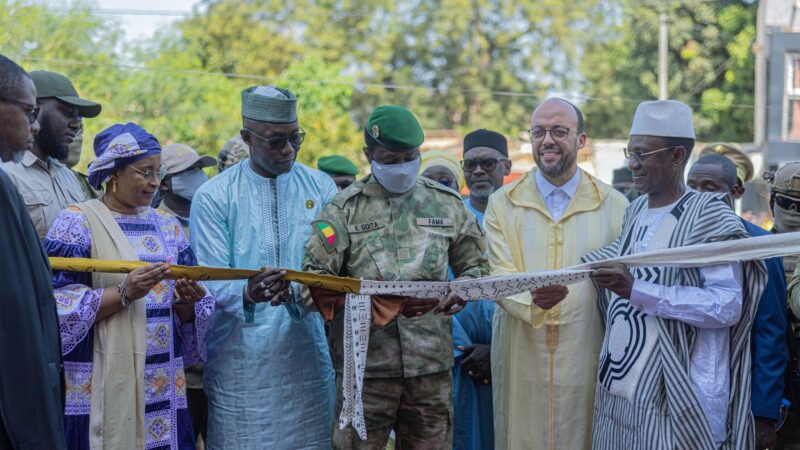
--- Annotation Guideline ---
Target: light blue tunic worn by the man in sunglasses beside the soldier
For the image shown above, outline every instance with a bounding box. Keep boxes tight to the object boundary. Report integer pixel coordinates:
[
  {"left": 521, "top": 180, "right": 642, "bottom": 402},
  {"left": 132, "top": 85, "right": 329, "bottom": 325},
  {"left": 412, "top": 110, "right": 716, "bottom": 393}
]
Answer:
[{"left": 190, "top": 160, "right": 337, "bottom": 449}]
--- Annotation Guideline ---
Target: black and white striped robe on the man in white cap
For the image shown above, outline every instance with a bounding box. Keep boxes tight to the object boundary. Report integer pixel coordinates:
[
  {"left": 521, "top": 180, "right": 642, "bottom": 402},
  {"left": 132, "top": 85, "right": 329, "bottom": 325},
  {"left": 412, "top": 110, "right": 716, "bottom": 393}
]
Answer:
[{"left": 584, "top": 190, "right": 767, "bottom": 450}]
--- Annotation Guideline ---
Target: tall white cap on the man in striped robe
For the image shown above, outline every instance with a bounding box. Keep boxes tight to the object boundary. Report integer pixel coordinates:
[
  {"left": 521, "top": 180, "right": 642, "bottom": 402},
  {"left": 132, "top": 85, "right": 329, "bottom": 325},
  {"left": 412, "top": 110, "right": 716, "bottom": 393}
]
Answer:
[{"left": 630, "top": 100, "right": 694, "bottom": 139}]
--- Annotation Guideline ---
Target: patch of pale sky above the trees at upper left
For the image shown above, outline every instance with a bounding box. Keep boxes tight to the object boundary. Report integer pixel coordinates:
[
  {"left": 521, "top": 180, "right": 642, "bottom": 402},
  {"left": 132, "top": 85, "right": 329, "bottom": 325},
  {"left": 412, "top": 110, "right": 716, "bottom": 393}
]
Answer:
[{"left": 94, "top": 0, "right": 198, "bottom": 42}]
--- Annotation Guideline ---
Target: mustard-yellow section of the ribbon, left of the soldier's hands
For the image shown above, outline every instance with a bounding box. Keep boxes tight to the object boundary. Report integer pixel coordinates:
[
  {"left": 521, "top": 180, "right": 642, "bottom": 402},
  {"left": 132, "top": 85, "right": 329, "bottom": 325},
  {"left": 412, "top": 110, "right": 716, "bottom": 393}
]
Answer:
[{"left": 50, "top": 257, "right": 361, "bottom": 294}]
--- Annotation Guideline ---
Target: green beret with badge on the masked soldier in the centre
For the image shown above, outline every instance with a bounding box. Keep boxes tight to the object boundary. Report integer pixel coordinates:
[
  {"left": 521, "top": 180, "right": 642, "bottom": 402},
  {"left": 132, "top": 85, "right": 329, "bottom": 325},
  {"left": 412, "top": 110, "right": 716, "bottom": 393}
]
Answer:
[{"left": 364, "top": 105, "right": 425, "bottom": 152}]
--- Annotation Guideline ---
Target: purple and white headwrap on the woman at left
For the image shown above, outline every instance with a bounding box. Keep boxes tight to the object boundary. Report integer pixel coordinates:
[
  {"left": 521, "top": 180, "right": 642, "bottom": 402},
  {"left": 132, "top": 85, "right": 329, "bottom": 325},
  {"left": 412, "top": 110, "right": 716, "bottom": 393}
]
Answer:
[{"left": 89, "top": 122, "right": 161, "bottom": 189}]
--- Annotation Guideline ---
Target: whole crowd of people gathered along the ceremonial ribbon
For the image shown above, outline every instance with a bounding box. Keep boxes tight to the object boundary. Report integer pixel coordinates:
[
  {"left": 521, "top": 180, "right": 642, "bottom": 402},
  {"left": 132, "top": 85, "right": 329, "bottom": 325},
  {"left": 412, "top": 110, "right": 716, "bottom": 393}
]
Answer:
[{"left": 0, "top": 51, "right": 800, "bottom": 449}]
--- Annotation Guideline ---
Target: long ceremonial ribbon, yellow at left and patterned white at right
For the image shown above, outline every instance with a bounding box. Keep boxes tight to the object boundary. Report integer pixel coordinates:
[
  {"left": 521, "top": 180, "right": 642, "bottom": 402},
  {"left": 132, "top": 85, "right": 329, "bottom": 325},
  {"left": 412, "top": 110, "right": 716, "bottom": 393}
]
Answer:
[{"left": 50, "top": 232, "right": 800, "bottom": 440}]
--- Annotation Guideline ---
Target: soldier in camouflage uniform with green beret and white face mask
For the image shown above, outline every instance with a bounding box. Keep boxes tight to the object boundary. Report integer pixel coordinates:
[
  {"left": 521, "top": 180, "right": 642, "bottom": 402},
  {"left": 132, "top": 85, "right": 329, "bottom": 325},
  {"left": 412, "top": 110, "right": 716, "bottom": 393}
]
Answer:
[{"left": 303, "top": 106, "right": 487, "bottom": 449}]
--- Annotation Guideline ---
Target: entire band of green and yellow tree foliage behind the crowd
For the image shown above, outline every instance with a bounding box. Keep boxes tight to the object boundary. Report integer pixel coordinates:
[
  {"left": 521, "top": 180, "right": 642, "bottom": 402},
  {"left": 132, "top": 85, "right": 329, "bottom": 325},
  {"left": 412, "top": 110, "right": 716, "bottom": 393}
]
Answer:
[{"left": 0, "top": 0, "right": 756, "bottom": 169}]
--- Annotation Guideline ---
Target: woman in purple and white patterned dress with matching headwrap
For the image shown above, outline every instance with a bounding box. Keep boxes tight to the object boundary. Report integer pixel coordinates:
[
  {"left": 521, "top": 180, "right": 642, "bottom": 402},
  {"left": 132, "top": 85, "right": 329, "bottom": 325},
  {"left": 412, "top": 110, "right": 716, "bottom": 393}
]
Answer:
[{"left": 44, "top": 123, "right": 214, "bottom": 449}]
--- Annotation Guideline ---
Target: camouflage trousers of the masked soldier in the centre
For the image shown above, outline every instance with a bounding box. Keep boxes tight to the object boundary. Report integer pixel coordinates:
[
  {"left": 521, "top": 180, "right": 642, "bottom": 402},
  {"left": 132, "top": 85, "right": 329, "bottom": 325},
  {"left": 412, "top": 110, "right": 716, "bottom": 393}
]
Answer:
[{"left": 333, "top": 370, "right": 453, "bottom": 450}]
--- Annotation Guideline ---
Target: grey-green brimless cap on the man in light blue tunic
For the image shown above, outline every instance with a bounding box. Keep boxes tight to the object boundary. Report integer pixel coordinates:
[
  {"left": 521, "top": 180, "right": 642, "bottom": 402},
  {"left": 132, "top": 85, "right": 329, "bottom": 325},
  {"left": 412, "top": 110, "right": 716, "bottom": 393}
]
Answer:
[{"left": 242, "top": 85, "right": 297, "bottom": 123}]
